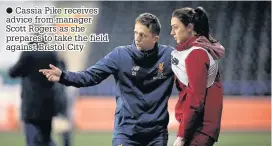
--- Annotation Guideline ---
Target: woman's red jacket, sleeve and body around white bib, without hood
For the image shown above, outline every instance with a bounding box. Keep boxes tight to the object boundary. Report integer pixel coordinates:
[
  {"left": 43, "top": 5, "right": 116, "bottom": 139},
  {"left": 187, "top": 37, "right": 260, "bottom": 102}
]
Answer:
[{"left": 175, "top": 44, "right": 223, "bottom": 141}]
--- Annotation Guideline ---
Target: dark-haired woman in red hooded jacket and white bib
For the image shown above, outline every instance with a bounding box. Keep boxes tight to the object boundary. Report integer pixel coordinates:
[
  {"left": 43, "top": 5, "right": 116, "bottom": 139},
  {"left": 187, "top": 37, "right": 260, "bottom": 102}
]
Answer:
[{"left": 171, "top": 7, "right": 225, "bottom": 146}]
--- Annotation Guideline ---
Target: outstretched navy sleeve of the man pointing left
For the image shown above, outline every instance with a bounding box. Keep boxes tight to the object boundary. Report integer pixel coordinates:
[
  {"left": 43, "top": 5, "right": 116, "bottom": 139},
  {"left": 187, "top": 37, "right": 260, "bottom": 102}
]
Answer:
[{"left": 59, "top": 48, "right": 118, "bottom": 87}]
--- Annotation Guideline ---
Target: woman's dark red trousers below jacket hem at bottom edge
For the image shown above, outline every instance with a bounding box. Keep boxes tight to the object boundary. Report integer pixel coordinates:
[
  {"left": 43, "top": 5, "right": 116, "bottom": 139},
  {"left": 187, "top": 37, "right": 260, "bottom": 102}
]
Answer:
[{"left": 184, "top": 132, "right": 215, "bottom": 146}]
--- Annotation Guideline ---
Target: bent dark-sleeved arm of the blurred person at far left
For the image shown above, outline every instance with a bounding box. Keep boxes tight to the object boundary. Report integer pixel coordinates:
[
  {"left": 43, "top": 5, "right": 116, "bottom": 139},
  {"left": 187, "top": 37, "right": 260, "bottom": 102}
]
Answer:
[{"left": 9, "top": 52, "right": 30, "bottom": 78}]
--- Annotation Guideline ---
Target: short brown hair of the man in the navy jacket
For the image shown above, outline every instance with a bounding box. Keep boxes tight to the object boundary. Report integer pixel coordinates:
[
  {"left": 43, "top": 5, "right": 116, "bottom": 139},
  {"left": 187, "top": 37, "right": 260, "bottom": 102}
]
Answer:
[{"left": 135, "top": 13, "right": 161, "bottom": 35}]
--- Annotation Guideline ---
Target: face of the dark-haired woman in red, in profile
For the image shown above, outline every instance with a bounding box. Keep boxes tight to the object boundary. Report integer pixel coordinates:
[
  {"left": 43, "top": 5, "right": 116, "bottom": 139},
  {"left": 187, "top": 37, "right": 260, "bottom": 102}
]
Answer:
[{"left": 171, "top": 17, "right": 193, "bottom": 44}]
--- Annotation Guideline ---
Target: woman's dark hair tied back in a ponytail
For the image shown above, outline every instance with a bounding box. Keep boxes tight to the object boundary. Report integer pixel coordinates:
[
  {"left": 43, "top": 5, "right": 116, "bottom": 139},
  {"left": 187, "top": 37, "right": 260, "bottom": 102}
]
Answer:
[{"left": 172, "top": 7, "right": 217, "bottom": 43}]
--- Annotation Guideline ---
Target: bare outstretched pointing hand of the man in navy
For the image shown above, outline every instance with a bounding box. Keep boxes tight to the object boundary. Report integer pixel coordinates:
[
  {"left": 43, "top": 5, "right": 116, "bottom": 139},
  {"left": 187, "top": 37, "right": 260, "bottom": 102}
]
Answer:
[{"left": 39, "top": 64, "right": 62, "bottom": 82}]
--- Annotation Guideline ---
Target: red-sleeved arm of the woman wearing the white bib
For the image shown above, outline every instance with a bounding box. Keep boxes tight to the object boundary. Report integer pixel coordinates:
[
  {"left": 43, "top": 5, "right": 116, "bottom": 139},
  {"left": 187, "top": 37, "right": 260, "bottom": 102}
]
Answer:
[{"left": 178, "top": 49, "right": 209, "bottom": 140}]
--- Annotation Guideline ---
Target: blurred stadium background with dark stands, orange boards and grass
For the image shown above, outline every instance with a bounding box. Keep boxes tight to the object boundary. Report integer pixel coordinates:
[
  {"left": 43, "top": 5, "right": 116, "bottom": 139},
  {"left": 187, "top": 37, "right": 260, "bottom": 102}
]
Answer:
[{"left": 0, "top": 1, "right": 271, "bottom": 146}]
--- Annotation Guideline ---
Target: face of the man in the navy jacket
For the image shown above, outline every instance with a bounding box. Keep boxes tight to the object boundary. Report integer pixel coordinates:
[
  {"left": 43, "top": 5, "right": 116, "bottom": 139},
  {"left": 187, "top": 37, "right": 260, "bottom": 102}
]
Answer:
[{"left": 134, "top": 22, "right": 159, "bottom": 51}]
